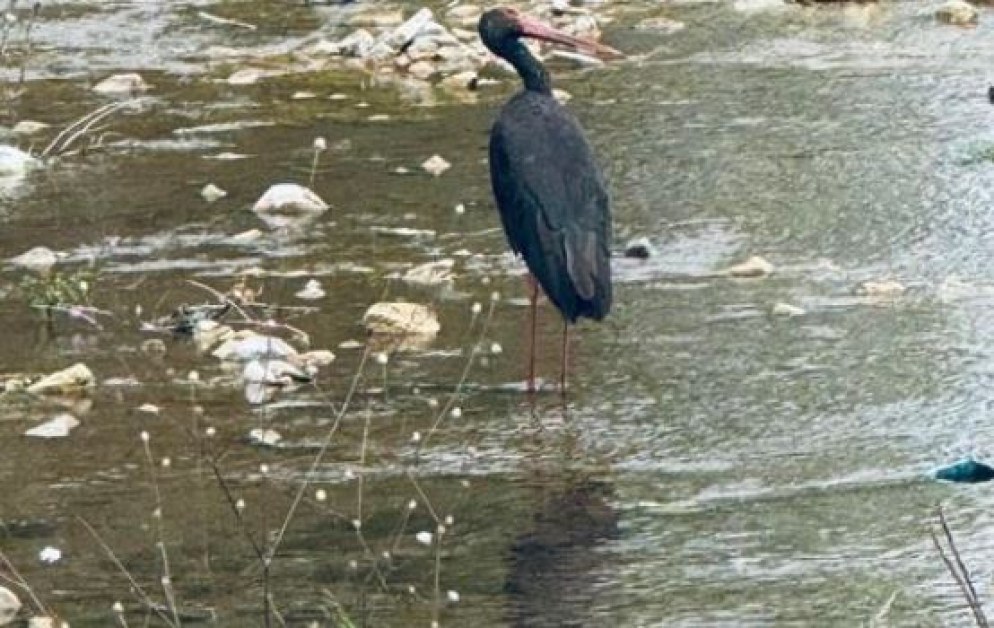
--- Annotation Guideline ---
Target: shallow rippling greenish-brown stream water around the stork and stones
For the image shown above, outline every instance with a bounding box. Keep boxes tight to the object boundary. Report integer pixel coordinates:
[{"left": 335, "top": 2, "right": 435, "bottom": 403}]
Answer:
[{"left": 0, "top": 2, "right": 994, "bottom": 626}]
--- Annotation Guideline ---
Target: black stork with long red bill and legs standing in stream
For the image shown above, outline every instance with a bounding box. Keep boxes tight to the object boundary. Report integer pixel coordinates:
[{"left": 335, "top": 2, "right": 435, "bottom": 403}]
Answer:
[{"left": 479, "top": 8, "right": 623, "bottom": 393}]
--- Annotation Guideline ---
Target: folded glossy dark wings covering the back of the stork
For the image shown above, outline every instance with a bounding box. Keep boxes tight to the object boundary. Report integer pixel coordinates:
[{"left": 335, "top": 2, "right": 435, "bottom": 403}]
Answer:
[{"left": 490, "top": 92, "right": 611, "bottom": 320}]
